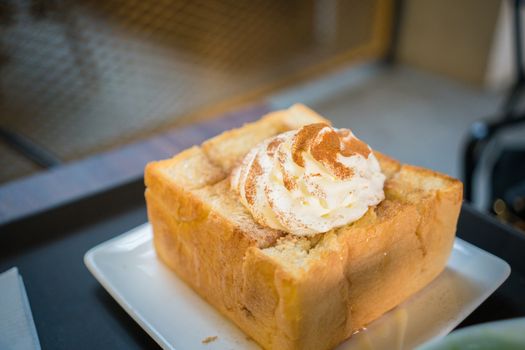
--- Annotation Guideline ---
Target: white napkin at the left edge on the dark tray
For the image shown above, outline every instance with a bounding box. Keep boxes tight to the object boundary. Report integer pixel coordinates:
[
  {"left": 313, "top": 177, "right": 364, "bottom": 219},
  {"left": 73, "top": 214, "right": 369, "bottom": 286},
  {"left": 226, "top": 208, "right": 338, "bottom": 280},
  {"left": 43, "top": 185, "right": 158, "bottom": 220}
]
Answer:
[{"left": 0, "top": 267, "right": 40, "bottom": 350}]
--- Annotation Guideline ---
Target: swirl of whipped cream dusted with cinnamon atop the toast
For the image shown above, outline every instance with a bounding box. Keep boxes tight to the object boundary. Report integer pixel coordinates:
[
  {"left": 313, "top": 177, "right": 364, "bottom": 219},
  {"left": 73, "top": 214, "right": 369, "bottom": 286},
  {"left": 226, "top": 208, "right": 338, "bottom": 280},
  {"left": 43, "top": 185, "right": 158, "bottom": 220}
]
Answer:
[{"left": 231, "top": 123, "right": 385, "bottom": 236}]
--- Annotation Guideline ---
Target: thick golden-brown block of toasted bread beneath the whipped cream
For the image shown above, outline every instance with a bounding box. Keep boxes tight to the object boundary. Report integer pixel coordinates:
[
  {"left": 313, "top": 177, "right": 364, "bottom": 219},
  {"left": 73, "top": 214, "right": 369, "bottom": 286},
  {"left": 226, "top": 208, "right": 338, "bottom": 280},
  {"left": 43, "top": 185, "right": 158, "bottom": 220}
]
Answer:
[{"left": 145, "top": 105, "right": 462, "bottom": 349}]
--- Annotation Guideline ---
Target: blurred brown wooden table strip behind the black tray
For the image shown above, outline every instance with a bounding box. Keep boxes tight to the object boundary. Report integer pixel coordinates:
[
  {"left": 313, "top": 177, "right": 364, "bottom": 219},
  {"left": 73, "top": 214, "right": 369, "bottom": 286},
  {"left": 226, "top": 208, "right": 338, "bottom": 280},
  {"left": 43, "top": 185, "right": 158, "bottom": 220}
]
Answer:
[{"left": 0, "top": 104, "right": 269, "bottom": 225}]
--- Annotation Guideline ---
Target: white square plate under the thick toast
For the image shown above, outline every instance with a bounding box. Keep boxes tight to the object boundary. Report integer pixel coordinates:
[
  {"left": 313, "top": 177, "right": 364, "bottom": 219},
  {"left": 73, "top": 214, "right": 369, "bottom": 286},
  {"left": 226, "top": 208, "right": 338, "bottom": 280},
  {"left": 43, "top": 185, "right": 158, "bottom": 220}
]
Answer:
[{"left": 84, "top": 224, "right": 510, "bottom": 350}]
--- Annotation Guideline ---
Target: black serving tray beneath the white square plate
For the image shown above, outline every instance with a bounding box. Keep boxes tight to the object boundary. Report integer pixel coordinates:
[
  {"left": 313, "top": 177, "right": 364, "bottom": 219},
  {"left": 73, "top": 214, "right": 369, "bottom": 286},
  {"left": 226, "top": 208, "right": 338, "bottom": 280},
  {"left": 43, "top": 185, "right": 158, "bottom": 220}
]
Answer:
[{"left": 0, "top": 181, "right": 525, "bottom": 349}]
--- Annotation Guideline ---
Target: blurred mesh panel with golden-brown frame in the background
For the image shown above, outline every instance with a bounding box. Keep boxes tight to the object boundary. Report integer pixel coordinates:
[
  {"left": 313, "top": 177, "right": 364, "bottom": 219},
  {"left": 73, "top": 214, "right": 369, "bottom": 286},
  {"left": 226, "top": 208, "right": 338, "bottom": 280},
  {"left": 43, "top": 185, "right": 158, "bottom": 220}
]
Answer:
[{"left": 0, "top": 0, "right": 384, "bottom": 182}]
